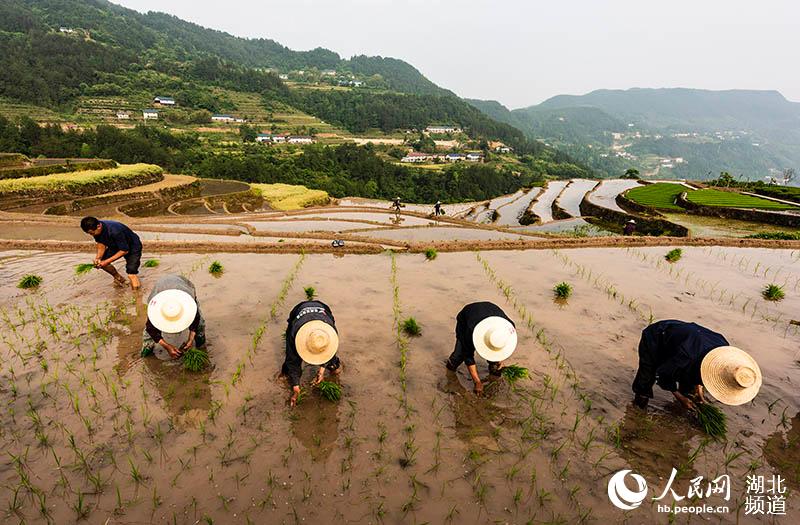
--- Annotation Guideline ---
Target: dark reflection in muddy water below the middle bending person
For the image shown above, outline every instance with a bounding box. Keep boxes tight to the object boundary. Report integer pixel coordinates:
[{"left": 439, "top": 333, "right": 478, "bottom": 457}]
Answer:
[{"left": 289, "top": 388, "right": 339, "bottom": 461}]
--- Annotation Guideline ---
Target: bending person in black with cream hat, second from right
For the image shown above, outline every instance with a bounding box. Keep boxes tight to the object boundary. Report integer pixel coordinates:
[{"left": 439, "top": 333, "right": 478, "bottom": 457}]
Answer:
[{"left": 445, "top": 302, "right": 517, "bottom": 395}]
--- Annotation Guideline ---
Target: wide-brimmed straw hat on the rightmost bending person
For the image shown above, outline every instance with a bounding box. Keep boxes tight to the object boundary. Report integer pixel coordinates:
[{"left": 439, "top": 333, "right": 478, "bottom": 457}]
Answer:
[{"left": 700, "top": 346, "right": 762, "bottom": 405}]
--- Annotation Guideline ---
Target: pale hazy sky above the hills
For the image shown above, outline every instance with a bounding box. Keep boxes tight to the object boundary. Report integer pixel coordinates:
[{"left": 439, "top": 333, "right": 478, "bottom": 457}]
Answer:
[{"left": 113, "top": 0, "right": 800, "bottom": 108}]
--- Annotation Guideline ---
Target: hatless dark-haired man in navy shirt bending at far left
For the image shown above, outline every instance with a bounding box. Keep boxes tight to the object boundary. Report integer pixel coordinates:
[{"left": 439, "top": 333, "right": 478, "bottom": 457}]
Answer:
[{"left": 81, "top": 217, "right": 142, "bottom": 290}]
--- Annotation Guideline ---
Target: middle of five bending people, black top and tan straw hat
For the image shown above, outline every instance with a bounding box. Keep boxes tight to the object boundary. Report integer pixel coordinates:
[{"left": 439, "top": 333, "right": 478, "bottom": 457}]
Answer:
[{"left": 280, "top": 301, "right": 342, "bottom": 406}]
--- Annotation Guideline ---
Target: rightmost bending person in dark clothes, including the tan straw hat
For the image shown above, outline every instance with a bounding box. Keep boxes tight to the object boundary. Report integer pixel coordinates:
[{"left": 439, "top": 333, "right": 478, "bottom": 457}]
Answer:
[{"left": 633, "top": 320, "right": 761, "bottom": 410}]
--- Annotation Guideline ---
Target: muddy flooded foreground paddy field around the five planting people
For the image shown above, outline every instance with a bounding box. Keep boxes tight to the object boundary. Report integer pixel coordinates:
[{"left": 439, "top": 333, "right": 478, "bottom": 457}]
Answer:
[{"left": 0, "top": 247, "right": 800, "bottom": 524}]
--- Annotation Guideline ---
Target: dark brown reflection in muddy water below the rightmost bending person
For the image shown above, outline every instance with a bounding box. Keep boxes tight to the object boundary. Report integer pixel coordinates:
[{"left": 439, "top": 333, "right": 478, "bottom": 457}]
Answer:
[{"left": 619, "top": 404, "right": 701, "bottom": 486}]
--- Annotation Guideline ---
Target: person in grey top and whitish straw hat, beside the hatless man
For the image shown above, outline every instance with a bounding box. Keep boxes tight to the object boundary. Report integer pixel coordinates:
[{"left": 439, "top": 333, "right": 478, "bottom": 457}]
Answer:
[{"left": 141, "top": 274, "right": 206, "bottom": 359}]
